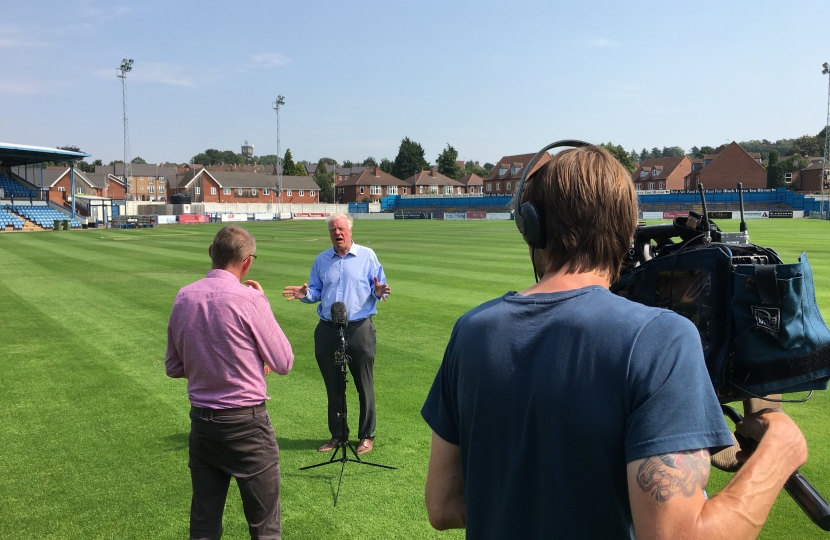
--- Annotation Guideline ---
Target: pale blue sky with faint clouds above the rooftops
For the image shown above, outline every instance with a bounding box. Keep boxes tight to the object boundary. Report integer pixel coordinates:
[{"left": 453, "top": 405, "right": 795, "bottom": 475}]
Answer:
[{"left": 0, "top": 0, "right": 830, "bottom": 164}]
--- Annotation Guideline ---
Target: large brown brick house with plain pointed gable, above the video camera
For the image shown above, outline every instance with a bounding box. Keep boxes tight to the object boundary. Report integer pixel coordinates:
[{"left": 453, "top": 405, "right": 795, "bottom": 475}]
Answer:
[{"left": 682, "top": 142, "right": 767, "bottom": 190}]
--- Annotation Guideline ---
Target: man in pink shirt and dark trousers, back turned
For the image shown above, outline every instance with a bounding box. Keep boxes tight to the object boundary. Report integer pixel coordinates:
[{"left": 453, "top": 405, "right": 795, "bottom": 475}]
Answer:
[{"left": 165, "top": 225, "right": 294, "bottom": 540}]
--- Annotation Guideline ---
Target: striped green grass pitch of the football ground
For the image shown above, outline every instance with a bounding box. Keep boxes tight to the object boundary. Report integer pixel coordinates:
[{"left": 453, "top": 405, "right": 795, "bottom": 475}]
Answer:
[{"left": 0, "top": 220, "right": 830, "bottom": 539}]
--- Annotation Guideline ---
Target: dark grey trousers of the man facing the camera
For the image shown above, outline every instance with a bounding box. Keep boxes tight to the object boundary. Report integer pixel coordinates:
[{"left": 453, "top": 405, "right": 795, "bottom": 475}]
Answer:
[{"left": 314, "top": 317, "right": 376, "bottom": 440}]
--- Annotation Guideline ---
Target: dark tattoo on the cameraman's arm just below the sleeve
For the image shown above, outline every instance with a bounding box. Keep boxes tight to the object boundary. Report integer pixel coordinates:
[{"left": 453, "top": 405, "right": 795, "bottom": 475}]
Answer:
[{"left": 637, "top": 450, "right": 710, "bottom": 502}]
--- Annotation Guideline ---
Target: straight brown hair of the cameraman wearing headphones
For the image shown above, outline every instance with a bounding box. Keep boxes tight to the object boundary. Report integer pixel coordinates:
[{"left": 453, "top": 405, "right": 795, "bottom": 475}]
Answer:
[{"left": 521, "top": 146, "right": 637, "bottom": 283}]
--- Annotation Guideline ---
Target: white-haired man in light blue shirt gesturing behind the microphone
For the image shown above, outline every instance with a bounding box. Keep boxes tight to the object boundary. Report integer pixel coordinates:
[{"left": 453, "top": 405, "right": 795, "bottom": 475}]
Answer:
[{"left": 282, "top": 214, "right": 392, "bottom": 454}]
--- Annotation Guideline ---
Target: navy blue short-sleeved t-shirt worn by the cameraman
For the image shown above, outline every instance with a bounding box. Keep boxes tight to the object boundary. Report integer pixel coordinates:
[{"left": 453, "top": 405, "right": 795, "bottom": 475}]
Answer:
[{"left": 421, "top": 286, "right": 733, "bottom": 539}]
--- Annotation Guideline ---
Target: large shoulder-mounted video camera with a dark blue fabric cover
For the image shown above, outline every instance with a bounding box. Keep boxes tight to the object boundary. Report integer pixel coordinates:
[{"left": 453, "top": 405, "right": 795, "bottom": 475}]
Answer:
[{"left": 611, "top": 205, "right": 830, "bottom": 402}]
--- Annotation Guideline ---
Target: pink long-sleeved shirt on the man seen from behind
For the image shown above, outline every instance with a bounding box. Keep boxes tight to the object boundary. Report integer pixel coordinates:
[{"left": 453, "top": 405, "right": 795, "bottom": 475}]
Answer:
[{"left": 164, "top": 270, "right": 294, "bottom": 409}]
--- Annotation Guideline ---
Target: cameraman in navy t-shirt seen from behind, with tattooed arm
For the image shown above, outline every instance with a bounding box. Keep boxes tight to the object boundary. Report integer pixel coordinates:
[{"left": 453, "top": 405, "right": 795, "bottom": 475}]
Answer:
[{"left": 422, "top": 146, "right": 807, "bottom": 540}]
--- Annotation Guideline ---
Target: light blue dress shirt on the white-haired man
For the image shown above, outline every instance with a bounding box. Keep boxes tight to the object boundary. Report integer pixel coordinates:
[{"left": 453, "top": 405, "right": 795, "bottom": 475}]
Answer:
[{"left": 301, "top": 242, "right": 386, "bottom": 321}]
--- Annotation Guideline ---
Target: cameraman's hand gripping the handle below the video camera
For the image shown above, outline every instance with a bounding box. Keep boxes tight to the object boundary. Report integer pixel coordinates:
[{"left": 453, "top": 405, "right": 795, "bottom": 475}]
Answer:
[{"left": 735, "top": 409, "right": 807, "bottom": 464}]
